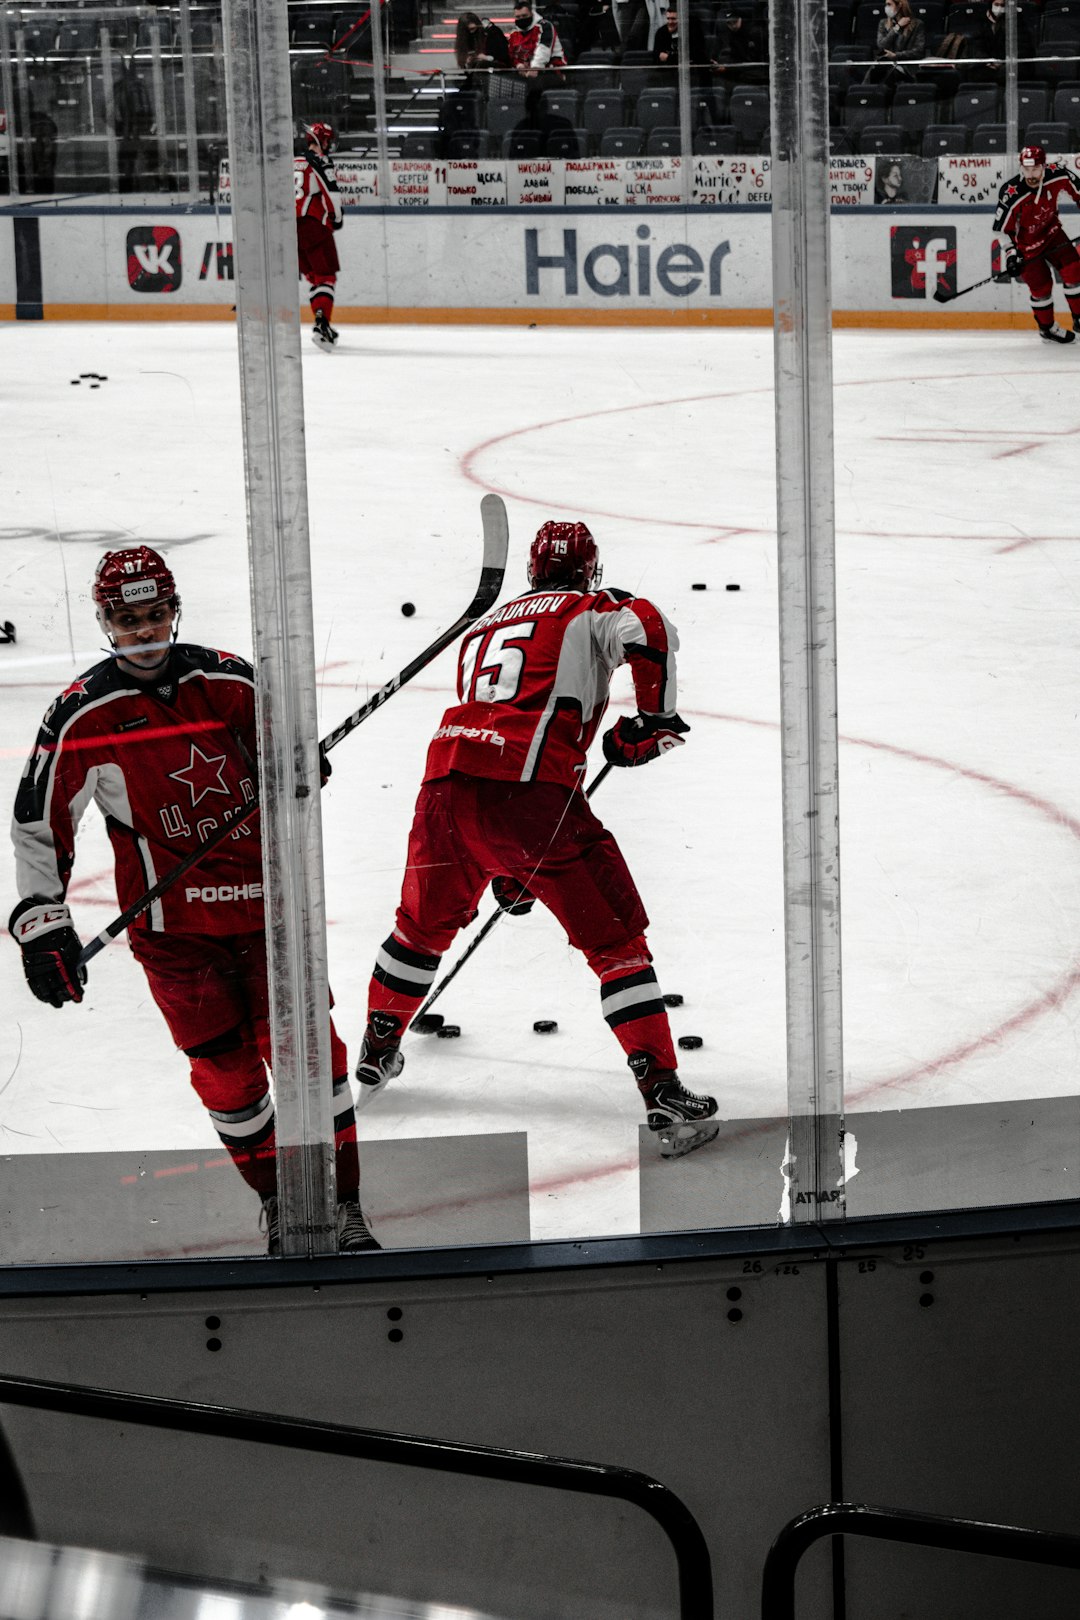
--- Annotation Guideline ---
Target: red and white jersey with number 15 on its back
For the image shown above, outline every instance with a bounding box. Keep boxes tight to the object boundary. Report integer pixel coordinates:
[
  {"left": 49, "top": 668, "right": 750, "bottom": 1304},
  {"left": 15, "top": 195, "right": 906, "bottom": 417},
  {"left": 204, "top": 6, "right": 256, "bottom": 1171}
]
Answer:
[{"left": 424, "top": 586, "right": 678, "bottom": 786}]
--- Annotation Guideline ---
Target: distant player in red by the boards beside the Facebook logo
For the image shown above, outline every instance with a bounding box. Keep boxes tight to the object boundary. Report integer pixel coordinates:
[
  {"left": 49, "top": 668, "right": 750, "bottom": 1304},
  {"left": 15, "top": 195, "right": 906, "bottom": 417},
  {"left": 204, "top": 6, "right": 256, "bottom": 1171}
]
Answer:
[{"left": 994, "top": 146, "right": 1080, "bottom": 343}]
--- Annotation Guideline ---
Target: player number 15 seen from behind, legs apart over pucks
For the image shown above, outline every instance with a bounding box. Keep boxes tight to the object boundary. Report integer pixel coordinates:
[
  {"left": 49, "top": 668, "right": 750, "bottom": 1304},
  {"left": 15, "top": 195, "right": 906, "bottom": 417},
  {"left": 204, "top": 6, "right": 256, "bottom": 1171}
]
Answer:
[{"left": 356, "top": 522, "right": 719, "bottom": 1155}]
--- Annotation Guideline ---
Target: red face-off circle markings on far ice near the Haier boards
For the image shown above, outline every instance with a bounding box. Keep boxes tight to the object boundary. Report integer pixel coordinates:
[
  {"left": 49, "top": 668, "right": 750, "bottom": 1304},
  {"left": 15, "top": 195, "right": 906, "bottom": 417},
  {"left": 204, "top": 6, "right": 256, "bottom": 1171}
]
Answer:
[{"left": 458, "top": 368, "right": 1080, "bottom": 551}]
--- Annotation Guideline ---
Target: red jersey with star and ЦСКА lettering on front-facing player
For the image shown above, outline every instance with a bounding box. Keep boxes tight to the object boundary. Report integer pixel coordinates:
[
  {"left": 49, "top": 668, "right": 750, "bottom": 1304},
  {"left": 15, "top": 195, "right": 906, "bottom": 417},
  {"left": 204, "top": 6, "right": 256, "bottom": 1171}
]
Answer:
[{"left": 11, "top": 645, "right": 262, "bottom": 933}]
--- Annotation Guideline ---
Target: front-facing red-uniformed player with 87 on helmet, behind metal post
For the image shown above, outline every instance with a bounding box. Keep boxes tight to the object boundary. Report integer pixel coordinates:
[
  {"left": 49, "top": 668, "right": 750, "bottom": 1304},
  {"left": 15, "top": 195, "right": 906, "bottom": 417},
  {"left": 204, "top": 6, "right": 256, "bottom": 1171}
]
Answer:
[{"left": 8, "top": 546, "right": 379, "bottom": 1254}]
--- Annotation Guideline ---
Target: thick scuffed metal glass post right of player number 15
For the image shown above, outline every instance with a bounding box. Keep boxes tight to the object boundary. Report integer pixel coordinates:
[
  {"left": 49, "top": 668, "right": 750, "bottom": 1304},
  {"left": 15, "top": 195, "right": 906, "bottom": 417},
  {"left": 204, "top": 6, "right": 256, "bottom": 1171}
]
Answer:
[{"left": 771, "top": 0, "right": 844, "bottom": 1220}]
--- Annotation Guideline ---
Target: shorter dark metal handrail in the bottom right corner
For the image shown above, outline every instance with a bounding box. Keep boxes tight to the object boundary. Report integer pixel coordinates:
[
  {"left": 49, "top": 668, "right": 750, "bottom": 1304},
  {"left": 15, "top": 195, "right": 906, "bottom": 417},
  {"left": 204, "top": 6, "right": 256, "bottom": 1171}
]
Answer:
[{"left": 761, "top": 1502, "right": 1080, "bottom": 1620}]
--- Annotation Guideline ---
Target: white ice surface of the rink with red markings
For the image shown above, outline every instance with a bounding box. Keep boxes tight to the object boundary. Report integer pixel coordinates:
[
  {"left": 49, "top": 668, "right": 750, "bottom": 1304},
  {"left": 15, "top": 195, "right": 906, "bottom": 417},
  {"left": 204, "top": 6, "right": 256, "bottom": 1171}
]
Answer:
[{"left": 0, "top": 324, "right": 1080, "bottom": 1239}]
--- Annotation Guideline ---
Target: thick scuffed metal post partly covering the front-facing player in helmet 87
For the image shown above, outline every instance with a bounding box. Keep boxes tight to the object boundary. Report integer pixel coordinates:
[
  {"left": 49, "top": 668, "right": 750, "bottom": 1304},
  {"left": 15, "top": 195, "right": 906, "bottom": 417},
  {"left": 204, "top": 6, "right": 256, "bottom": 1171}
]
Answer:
[{"left": 223, "top": 0, "right": 337, "bottom": 1254}]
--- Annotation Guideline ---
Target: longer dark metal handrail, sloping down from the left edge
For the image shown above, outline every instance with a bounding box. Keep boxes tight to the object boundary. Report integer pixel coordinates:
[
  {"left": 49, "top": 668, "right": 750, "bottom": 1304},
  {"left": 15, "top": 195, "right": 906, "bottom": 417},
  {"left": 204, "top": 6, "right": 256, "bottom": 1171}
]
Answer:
[{"left": 0, "top": 1377, "right": 712, "bottom": 1620}]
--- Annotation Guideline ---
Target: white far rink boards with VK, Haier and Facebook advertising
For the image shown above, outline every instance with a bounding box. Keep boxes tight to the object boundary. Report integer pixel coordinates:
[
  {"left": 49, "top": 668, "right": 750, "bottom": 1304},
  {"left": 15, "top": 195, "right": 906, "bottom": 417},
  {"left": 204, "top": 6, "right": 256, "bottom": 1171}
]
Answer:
[{"left": 0, "top": 194, "right": 1049, "bottom": 326}]
